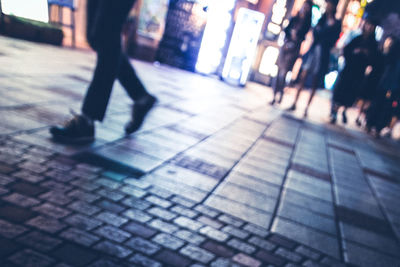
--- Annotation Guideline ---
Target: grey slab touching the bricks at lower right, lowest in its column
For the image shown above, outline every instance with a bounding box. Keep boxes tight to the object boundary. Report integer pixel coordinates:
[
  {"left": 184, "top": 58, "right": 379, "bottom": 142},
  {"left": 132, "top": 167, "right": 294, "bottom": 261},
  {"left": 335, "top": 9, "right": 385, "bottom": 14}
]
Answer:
[{"left": 272, "top": 218, "right": 340, "bottom": 258}]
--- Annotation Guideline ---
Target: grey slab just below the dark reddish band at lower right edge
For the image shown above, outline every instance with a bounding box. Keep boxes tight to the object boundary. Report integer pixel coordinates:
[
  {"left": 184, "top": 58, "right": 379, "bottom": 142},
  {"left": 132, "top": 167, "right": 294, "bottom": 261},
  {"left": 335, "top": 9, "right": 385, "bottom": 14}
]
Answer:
[{"left": 340, "top": 222, "right": 400, "bottom": 256}]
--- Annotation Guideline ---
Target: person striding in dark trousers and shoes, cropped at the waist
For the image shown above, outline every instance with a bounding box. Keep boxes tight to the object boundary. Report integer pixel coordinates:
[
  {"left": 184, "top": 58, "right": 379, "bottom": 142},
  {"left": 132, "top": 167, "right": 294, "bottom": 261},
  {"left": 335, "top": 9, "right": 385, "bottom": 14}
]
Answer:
[{"left": 50, "top": 0, "right": 156, "bottom": 143}]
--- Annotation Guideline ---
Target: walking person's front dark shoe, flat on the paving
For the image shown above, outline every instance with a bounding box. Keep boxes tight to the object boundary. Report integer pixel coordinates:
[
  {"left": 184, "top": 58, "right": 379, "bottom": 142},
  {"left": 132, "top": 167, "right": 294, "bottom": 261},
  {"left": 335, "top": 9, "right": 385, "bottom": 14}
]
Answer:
[{"left": 50, "top": 115, "right": 94, "bottom": 145}]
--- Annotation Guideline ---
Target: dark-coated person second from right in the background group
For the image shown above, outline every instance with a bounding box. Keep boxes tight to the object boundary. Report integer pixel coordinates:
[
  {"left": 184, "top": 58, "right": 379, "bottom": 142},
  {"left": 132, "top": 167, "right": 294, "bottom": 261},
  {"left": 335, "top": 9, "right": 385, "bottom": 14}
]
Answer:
[{"left": 331, "top": 17, "right": 378, "bottom": 123}]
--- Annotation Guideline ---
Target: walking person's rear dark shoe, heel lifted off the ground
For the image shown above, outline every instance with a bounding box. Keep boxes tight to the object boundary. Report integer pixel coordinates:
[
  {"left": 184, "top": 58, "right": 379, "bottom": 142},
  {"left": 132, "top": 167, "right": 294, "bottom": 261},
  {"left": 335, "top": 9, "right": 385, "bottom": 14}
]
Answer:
[{"left": 125, "top": 95, "right": 157, "bottom": 134}]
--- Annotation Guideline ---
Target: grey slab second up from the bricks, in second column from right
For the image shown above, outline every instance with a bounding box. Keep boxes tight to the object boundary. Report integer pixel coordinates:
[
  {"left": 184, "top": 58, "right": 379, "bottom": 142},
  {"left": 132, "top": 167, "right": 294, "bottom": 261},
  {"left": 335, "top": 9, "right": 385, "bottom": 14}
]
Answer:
[{"left": 278, "top": 202, "right": 337, "bottom": 235}]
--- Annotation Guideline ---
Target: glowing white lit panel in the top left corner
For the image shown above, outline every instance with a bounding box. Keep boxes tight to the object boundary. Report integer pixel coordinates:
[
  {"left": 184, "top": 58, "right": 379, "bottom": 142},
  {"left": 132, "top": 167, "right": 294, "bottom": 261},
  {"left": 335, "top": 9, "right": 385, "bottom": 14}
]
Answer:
[{"left": 1, "top": 0, "right": 49, "bottom": 22}]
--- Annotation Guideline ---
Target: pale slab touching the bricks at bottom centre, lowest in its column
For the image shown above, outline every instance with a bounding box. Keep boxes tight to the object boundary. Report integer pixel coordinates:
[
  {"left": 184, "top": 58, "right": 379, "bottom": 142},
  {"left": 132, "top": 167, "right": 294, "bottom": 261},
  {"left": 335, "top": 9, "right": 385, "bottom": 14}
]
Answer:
[{"left": 205, "top": 195, "right": 272, "bottom": 228}]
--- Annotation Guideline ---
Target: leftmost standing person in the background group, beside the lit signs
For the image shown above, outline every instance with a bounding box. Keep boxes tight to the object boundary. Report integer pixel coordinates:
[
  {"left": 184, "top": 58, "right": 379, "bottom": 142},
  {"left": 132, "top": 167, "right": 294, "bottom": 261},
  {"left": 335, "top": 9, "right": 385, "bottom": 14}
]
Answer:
[{"left": 270, "top": 1, "right": 313, "bottom": 105}]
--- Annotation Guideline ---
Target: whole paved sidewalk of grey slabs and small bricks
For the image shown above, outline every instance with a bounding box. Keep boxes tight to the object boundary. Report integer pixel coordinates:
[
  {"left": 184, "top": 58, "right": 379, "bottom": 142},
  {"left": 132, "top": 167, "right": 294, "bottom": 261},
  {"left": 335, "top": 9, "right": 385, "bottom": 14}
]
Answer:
[{"left": 0, "top": 36, "right": 400, "bottom": 267}]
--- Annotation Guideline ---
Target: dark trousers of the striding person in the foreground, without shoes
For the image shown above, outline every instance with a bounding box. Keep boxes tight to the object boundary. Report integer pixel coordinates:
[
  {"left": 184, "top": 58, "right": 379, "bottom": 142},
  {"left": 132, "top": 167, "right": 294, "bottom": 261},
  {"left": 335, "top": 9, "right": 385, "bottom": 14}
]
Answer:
[{"left": 82, "top": 0, "right": 146, "bottom": 121}]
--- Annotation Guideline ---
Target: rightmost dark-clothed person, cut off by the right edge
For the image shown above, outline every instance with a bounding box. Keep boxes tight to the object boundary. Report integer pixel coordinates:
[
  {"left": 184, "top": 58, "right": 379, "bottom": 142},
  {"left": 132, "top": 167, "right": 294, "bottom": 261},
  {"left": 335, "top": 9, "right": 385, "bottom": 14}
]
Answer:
[{"left": 366, "top": 36, "right": 400, "bottom": 137}]
